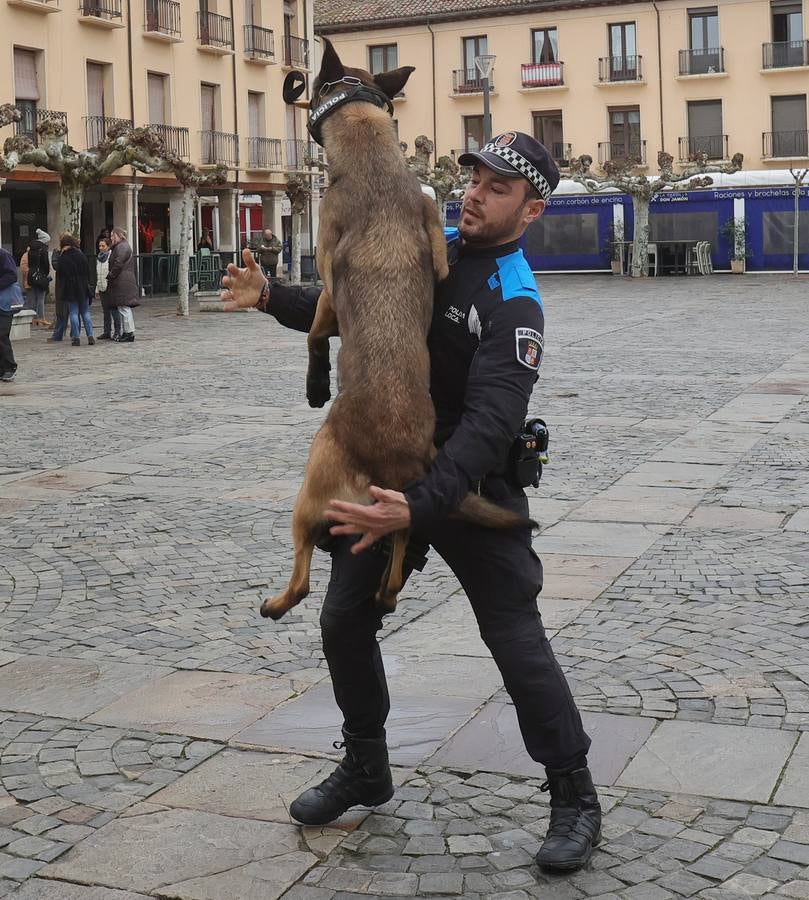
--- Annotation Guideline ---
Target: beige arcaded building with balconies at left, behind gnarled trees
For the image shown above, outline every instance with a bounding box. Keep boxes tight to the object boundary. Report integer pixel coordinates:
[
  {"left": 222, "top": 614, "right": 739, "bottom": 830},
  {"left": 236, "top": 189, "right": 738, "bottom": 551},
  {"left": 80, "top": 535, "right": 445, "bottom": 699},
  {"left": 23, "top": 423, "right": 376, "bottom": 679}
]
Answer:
[{"left": 0, "top": 0, "right": 317, "bottom": 280}]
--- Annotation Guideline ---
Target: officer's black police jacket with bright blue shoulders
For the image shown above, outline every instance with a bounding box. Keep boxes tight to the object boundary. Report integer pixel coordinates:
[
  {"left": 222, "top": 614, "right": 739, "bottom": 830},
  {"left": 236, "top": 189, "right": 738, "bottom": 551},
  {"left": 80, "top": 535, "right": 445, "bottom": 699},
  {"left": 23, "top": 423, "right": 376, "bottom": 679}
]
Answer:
[{"left": 268, "top": 229, "right": 545, "bottom": 531}]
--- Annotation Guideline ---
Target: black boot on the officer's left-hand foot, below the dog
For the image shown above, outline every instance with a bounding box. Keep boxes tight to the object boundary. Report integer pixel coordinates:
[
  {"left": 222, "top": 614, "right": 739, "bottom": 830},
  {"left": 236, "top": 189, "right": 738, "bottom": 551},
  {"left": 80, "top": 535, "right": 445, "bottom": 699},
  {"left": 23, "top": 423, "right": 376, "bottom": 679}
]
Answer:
[{"left": 289, "top": 729, "right": 393, "bottom": 825}]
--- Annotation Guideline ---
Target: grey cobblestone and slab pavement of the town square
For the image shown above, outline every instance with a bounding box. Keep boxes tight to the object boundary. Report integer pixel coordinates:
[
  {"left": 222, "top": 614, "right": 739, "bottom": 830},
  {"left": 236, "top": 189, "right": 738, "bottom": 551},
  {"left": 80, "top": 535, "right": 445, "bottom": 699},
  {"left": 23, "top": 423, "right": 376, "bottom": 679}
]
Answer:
[{"left": 0, "top": 275, "right": 809, "bottom": 900}]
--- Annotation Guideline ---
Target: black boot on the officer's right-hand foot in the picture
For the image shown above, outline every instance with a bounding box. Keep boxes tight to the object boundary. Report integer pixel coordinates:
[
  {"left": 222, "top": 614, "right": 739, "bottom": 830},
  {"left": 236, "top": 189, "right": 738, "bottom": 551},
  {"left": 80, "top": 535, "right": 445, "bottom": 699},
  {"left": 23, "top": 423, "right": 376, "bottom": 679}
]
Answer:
[{"left": 536, "top": 768, "right": 601, "bottom": 870}]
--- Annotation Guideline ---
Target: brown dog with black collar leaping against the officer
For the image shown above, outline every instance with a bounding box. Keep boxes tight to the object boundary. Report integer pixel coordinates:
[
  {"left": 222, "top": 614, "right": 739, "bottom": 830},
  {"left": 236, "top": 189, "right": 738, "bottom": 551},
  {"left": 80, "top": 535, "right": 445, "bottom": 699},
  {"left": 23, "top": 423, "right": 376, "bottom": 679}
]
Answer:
[{"left": 261, "top": 39, "right": 527, "bottom": 619}]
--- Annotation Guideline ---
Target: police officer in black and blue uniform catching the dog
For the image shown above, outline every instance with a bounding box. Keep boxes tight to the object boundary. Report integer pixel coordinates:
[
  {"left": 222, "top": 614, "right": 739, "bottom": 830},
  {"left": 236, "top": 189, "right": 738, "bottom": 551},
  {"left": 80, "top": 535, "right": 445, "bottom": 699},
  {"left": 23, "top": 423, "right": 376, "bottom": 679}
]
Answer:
[{"left": 222, "top": 131, "right": 601, "bottom": 869}]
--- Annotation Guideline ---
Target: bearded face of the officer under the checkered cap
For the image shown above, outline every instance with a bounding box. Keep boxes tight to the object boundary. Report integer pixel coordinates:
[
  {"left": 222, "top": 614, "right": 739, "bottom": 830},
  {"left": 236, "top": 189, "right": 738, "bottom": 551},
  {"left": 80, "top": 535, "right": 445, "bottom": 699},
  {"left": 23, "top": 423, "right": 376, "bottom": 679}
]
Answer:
[{"left": 458, "top": 165, "right": 545, "bottom": 247}]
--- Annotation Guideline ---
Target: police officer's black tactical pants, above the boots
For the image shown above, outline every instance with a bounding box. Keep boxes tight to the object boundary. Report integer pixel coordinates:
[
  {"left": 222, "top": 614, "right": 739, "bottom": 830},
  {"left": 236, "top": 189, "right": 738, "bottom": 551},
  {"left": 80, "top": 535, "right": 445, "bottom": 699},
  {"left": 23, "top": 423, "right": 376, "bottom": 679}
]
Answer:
[{"left": 320, "top": 489, "right": 590, "bottom": 769}]
